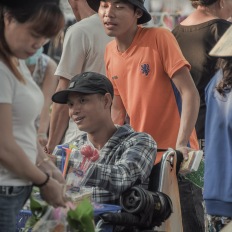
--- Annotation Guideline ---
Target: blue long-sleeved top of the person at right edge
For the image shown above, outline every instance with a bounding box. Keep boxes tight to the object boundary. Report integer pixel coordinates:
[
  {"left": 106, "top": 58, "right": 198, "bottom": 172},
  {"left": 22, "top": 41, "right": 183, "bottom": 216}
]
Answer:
[{"left": 204, "top": 70, "right": 232, "bottom": 217}]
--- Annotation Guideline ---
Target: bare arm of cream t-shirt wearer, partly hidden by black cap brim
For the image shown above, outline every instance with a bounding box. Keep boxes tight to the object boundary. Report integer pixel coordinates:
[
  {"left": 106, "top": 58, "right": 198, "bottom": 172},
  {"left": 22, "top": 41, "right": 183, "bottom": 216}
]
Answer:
[{"left": 46, "top": 77, "right": 69, "bottom": 153}]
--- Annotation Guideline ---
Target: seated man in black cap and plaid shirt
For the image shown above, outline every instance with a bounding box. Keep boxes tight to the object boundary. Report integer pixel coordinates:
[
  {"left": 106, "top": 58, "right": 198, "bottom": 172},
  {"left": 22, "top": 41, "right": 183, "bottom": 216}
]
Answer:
[{"left": 52, "top": 72, "right": 157, "bottom": 201}]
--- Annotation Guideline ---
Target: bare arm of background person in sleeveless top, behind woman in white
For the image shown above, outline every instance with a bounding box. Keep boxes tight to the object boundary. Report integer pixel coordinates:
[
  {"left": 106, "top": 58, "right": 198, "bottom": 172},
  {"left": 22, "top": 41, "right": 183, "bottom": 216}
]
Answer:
[{"left": 38, "top": 59, "right": 58, "bottom": 146}]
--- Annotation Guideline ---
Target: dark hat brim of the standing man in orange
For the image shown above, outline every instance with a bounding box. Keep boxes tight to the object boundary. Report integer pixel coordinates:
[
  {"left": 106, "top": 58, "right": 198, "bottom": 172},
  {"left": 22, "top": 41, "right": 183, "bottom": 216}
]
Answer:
[{"left": 87, "top": 0, "right": 151, "bottom": 24}]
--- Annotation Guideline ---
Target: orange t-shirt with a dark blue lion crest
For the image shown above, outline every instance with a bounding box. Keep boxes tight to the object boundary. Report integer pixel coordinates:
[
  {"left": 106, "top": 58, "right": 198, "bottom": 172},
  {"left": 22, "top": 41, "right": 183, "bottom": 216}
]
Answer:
[{"left": 105, "top": 27, "right": 198, "bottom": 162}]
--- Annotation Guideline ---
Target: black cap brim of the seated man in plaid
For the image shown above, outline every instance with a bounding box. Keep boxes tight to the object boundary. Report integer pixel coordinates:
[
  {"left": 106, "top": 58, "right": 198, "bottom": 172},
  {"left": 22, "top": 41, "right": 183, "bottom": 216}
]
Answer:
[{"left": 52, "top": 89, "right": 102, "bottom": 104}]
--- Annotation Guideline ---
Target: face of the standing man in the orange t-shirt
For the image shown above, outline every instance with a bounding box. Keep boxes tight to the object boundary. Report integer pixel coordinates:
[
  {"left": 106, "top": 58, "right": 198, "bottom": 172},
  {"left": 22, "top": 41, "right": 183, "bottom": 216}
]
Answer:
[{"left": 98, "top": 0, "right": 138, "bottom": 39}]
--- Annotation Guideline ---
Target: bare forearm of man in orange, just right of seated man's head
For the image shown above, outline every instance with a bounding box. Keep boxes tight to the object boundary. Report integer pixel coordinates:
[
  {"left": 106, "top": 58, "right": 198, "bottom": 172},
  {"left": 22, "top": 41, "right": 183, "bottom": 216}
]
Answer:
[{"left": 111, "top": 96, "right": 126, "bottom": 125}]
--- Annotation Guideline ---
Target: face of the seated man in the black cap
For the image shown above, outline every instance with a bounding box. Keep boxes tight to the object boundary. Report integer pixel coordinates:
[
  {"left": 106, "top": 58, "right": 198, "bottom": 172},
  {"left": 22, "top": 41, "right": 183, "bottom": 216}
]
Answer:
[{"left": 67, "top": 92, "right": 107, "bottom": 133}]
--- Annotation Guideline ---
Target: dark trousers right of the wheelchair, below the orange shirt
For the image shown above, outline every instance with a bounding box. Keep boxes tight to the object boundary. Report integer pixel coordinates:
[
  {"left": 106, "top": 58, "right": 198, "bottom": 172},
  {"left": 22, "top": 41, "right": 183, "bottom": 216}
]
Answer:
[{"left": 178, "top": 176, "right": 205, "bottom": 232}]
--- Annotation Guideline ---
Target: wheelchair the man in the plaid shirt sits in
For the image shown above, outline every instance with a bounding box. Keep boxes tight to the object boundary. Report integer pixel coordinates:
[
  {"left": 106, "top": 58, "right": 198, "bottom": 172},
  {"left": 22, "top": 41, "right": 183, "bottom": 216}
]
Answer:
[{"left": 97, "top": 148, "right": 183, "bottom": 232}]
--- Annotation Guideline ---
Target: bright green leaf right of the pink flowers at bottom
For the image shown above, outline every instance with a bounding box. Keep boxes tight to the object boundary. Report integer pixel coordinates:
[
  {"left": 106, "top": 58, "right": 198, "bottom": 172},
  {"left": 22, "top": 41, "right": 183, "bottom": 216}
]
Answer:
[{"left": 67, "top": 199, "right": 94, "bottom": 232}]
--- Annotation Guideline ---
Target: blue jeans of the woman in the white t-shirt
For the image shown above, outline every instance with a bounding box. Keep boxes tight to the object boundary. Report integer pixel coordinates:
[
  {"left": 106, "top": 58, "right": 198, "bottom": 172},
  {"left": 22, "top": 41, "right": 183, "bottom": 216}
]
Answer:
[{"left": 0, "top": 186, "right": 32, "bottom": 232}]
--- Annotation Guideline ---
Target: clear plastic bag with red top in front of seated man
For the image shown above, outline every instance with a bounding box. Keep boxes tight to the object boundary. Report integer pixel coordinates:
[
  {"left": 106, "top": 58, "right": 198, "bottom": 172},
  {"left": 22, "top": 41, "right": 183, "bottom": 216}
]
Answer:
[{"left": 53, "top": 142, "right": 99, "bottom": 205}]
